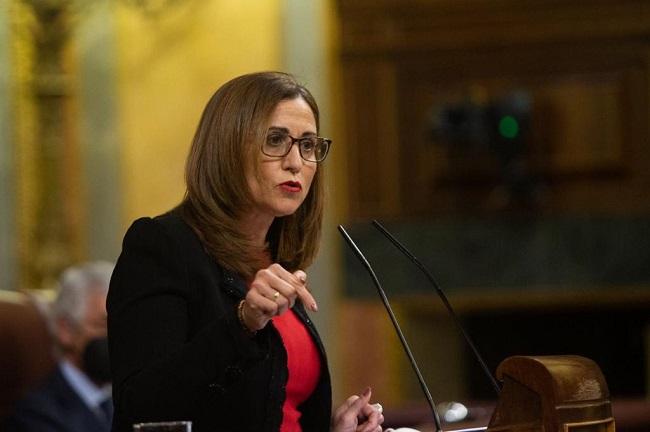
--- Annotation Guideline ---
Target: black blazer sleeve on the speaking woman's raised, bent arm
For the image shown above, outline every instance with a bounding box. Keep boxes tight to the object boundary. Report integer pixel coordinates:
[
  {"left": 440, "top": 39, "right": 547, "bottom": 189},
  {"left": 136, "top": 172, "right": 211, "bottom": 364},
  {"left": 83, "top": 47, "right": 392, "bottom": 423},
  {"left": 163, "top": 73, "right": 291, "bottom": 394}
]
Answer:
[{"left": 107, "top": 218, "right": 268, "bottom": 424}]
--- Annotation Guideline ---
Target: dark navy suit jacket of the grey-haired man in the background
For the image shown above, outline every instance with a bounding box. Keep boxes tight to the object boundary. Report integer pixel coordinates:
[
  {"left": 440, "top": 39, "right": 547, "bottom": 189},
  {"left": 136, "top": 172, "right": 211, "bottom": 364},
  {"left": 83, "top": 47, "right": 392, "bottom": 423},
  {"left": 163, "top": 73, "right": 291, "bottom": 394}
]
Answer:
[{"left": 7, "top": 367, "right": 111, "bottom": 432}]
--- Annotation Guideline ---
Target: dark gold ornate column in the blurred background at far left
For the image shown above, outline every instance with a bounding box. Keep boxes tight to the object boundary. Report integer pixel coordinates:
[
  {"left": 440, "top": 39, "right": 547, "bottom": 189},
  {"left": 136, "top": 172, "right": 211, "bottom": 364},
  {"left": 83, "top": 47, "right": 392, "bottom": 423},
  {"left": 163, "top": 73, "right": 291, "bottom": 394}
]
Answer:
[{"left": 23, "top": 0, "right": 79, "bottom": 288}]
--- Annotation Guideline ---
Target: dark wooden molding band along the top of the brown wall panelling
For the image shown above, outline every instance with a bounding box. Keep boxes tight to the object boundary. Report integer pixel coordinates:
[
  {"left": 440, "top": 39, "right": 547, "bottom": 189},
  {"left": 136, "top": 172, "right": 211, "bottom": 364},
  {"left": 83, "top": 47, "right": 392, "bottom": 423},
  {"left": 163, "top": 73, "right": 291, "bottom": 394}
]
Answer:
[{"left": 339, "top": 0, "right": 650, "bottom": 56}]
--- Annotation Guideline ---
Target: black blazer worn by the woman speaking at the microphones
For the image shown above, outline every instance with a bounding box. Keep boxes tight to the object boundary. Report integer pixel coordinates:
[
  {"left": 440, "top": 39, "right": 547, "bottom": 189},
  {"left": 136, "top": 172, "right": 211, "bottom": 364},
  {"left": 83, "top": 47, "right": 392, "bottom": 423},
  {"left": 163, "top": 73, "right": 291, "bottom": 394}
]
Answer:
[{"left": 107, "top": 212, "right": 331, "bottom": 432}]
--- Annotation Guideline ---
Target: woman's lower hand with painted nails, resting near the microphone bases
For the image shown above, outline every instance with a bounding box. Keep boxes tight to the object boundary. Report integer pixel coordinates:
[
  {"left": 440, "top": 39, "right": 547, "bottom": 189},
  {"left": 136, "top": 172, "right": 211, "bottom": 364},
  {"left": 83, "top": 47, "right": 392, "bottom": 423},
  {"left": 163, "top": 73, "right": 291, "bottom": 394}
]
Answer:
[{"left": 332, "top": 387, "right": 384, "bottom": 432}]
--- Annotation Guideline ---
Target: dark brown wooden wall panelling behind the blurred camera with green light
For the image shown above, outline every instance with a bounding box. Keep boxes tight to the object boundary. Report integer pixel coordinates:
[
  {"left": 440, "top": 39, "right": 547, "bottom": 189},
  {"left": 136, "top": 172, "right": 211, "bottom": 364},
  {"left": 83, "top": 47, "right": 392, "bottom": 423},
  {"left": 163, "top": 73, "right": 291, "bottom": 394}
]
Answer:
[{"left": 339, "top": 0, "right": 650, "bottom": 219}]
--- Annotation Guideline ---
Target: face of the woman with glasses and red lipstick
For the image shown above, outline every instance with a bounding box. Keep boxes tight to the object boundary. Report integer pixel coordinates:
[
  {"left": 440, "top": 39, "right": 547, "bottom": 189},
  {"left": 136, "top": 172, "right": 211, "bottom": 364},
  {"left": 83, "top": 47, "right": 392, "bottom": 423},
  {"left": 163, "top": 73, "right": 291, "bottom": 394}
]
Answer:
[{"left": 246, "top": 97, "right": 317, "bottom": 221}]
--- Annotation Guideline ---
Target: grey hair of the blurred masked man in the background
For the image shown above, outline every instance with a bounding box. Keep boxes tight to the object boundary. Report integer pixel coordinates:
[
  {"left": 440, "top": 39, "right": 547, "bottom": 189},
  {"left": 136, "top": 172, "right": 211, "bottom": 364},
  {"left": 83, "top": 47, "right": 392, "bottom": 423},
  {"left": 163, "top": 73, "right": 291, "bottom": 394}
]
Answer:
[{"left": 52, "top": 261, "right": 115, "bottom": 325}]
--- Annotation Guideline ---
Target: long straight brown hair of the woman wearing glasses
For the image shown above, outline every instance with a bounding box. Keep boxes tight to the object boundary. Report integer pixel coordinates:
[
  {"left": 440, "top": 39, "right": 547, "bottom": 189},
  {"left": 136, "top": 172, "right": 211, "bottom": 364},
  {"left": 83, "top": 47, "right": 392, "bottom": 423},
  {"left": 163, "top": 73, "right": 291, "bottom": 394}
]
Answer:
[{"left": 181, "top": 72, "right": 324, "bottom": 279}]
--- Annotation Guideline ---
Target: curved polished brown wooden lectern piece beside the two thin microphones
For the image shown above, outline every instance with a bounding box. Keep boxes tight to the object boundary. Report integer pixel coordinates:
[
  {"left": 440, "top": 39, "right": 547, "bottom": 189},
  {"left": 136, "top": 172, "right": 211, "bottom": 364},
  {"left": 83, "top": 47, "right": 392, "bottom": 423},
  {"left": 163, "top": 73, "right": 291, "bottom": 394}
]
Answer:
[{"left": 487, "top": 356, "right": 615, "bottom": 432}]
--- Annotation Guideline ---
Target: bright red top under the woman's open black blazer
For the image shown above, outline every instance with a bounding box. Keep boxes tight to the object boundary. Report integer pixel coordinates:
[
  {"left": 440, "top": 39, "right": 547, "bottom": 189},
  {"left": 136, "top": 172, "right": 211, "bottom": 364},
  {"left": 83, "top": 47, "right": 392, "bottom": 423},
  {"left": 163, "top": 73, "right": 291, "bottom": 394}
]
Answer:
[{"left": 273, "top": 310, "right": 321, "bottom": 432}]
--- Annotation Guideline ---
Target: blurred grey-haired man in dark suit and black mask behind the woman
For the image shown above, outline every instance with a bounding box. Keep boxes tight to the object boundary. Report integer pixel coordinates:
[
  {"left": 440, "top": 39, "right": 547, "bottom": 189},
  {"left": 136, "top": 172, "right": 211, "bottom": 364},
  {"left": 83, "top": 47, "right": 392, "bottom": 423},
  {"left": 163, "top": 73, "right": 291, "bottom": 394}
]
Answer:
[{"left": 8, "top": 261, "right": 113, "bottom": 432}]
